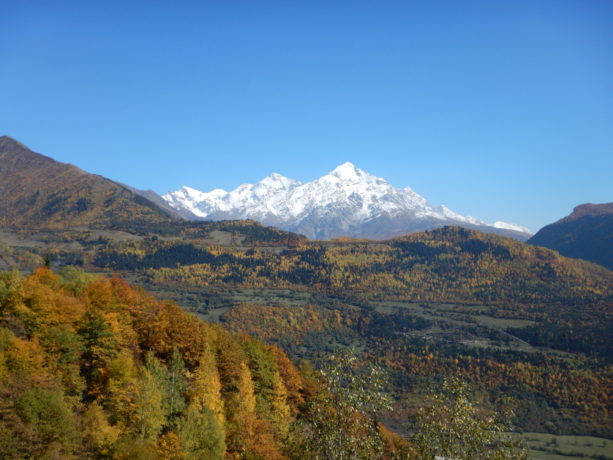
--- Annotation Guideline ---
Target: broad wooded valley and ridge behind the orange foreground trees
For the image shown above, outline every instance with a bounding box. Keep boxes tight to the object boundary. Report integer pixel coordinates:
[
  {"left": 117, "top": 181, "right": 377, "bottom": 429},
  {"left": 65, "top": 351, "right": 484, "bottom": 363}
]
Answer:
[{"left": 82, "top": 227, "right": 613, "bottom": 436}]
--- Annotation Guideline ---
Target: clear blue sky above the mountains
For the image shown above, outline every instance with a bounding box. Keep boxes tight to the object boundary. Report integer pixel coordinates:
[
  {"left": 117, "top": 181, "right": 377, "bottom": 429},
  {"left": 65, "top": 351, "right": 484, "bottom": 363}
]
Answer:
[{"left": 0, "top": 0, "right": 613, "bottom": 230}]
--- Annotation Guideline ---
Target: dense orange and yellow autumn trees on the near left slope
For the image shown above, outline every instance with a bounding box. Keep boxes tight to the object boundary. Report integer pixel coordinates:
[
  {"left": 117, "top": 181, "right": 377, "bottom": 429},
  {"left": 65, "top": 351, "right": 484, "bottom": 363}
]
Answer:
[{"left": 0, "top": 269, "right": 309, "bottom": 459}]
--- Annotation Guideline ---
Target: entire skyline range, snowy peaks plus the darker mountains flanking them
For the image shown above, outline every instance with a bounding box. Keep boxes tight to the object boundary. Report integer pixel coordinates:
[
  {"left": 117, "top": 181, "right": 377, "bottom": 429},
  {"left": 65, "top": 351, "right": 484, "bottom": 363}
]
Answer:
[{"left": 8, "top": 136, "right": 613, "bottom": 260}]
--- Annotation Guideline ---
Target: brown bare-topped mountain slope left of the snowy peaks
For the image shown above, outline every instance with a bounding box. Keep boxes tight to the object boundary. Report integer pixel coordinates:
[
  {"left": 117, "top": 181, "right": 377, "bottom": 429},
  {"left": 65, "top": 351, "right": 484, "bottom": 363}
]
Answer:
[{"left": 0, "top": 136, "right": 173, "bottom": 230}]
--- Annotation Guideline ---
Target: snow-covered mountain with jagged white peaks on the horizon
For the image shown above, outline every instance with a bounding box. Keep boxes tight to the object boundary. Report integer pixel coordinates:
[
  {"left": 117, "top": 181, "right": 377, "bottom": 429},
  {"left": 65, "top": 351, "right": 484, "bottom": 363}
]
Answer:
[{"left": 162, "top": 163, "right": 531, "bottom": 240}]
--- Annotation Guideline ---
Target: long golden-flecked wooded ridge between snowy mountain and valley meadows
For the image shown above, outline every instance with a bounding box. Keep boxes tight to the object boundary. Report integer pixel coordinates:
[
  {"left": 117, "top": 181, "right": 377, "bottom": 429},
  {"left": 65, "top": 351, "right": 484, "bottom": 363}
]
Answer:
[{"left": 125, "top": 227, "right": 613, "bottom": 308}]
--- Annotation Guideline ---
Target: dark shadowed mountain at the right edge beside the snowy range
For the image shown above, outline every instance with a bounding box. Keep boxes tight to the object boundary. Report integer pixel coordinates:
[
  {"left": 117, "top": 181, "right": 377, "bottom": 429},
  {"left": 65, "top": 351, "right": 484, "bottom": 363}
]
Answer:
[{"left": 528, "top": 203, "right": 613, "bottom": 270}]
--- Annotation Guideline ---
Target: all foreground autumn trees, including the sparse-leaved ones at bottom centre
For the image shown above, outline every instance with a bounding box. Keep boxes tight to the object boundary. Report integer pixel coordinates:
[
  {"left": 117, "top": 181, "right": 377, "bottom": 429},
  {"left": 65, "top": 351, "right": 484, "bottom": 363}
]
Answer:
[{"left": 0, "top": 267, "right": 524, "bottom": 460}]
